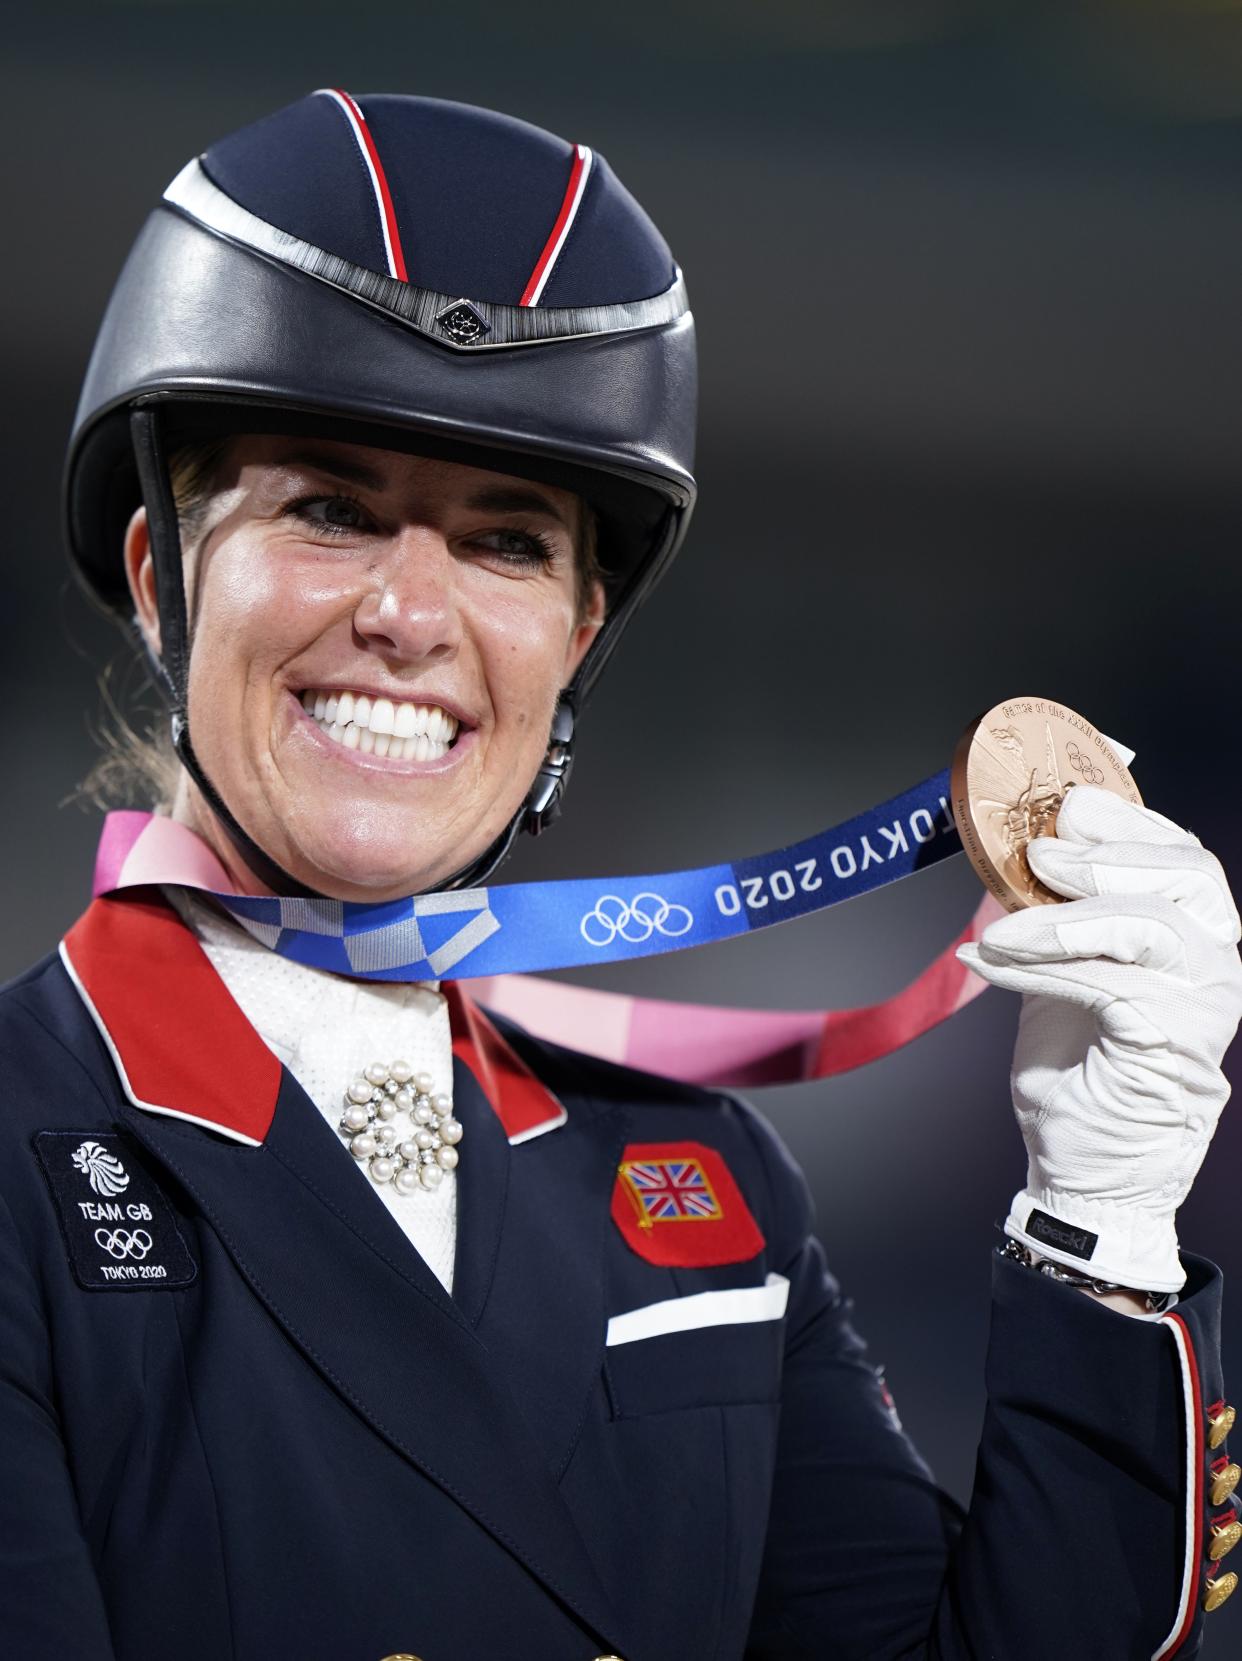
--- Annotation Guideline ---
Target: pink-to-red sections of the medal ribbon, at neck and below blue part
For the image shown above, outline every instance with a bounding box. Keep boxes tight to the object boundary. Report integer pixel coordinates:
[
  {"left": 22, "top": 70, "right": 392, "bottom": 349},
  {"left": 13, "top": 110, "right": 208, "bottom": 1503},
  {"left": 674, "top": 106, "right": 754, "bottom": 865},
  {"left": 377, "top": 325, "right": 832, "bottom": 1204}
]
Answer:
[{"left": 93, "top": 812, "right": 1003, "bottom": 1088}]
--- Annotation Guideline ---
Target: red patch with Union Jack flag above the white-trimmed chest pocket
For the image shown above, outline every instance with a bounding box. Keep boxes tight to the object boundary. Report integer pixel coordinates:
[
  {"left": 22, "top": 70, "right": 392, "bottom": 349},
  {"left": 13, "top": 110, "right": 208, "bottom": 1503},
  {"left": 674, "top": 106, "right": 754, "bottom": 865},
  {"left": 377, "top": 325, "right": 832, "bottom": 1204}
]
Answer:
[{"left": 613, "top": 1143, "right": 764, "bottom": 1269}]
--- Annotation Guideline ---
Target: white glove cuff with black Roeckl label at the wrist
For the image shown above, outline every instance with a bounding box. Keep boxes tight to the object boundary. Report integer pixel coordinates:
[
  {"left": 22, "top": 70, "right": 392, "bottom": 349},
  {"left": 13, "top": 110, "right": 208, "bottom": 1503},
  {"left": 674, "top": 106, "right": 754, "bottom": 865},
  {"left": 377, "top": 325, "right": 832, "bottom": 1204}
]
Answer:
[{"left": 1005, "top": 1189, "right": 1186, "bottom": 1292}]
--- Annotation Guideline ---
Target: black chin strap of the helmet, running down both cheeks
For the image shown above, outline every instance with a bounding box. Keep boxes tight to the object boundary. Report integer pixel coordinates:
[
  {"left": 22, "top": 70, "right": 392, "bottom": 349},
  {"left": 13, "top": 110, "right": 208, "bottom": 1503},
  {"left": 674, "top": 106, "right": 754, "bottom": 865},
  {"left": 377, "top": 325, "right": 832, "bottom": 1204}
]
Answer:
[{"left": 130, "top": 404, "right": 575, "bottom": 899}]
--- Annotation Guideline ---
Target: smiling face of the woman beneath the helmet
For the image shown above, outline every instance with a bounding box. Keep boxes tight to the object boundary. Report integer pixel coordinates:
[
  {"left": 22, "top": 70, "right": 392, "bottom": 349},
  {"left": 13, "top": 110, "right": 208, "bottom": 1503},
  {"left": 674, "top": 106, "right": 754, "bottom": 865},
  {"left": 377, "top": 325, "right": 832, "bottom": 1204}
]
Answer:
[{"left": 126, "top": 437, "right": 603, "bottom": 900}]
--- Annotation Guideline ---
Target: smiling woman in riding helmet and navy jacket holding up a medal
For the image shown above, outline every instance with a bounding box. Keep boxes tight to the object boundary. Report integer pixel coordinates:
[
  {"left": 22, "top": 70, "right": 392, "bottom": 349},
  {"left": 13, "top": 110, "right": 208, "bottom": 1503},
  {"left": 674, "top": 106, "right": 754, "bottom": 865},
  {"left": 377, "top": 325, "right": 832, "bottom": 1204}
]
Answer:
[{"left": 0, "top": 91, "right": 1242, "bottom": 1661}]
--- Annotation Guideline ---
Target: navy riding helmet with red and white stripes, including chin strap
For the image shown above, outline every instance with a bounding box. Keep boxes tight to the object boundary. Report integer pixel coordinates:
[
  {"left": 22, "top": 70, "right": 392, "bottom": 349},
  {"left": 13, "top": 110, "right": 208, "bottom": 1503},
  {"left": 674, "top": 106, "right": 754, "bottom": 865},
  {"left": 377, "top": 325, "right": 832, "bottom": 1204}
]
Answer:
[{"left": 66, "top": 90, "right": 696, "bottom": 892}]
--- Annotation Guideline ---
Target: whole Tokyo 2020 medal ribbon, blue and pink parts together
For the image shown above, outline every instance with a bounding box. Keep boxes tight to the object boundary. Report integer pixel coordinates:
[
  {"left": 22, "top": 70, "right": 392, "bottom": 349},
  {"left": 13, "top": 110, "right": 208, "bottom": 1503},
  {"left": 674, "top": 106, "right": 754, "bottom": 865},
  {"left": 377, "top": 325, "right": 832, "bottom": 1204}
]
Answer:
[{"left": 95, "top": 771, "right": 1000, "bottom": 1086}]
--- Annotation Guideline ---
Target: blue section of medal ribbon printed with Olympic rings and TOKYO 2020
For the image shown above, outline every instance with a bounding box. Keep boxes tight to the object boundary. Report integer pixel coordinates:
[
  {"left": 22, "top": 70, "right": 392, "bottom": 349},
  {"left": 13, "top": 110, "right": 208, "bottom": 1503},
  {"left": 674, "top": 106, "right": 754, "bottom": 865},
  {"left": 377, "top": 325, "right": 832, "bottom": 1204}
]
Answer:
[{"left": 214, "top": 769, "right": 961, "bottom": 980}]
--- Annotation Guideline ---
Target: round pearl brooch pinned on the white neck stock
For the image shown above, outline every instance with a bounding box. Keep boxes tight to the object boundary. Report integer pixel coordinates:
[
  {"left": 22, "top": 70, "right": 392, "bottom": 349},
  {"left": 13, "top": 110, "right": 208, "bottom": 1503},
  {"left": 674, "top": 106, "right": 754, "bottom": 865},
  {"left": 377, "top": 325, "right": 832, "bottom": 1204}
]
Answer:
[{"left": 339, "top": 1061, "right": 462, "bottom": 1194}]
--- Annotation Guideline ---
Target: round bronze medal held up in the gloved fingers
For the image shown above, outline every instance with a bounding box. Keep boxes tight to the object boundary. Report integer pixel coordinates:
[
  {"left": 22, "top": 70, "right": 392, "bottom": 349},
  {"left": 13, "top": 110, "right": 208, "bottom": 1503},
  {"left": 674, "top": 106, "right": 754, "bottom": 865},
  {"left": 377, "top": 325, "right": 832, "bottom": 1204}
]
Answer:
[{"left": 950, "top": 698, "right": 1142, "bottom": 912}]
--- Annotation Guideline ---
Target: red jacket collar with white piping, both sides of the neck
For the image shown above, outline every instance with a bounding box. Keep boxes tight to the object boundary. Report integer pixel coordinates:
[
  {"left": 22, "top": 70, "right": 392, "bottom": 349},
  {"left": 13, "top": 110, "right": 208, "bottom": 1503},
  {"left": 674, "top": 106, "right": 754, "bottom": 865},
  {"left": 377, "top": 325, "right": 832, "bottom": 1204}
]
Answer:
[{"left": 60, "top": 890, "right": 566, "bottom": 1148}]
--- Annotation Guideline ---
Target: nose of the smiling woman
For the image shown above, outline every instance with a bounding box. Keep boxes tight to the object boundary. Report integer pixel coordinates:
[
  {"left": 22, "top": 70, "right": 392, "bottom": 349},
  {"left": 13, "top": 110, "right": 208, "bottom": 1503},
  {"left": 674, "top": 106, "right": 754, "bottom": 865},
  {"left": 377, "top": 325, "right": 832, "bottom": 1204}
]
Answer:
[{"left": 354, "top": 525, "right": 462, "bottom": 663}]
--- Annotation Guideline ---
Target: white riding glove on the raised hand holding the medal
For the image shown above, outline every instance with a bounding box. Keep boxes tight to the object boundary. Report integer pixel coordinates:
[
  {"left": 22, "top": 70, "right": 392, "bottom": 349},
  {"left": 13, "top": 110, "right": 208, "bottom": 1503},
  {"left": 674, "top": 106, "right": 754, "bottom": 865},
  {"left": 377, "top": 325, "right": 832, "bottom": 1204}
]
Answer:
[{"left": 958, "top": 784, "right": 1242, "bottom": 1292}]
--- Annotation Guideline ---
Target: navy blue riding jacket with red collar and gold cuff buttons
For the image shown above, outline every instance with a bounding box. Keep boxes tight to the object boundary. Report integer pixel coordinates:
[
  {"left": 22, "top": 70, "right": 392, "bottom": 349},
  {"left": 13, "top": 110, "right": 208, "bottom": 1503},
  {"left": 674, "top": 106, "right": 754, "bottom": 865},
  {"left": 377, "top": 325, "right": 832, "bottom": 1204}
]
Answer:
[{"left": 0, "top": 895, "right": 1232, "bottom": 1661}]
